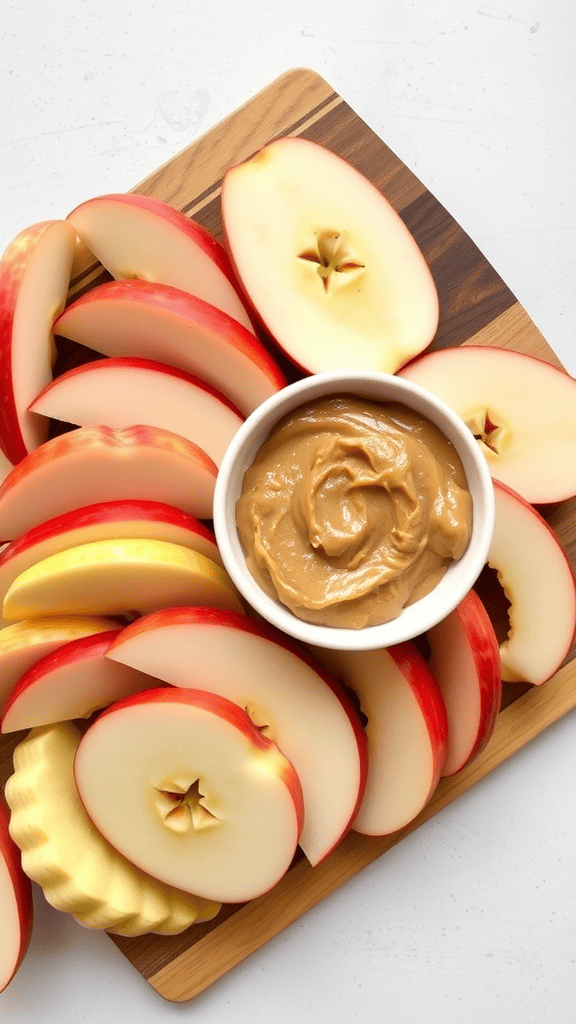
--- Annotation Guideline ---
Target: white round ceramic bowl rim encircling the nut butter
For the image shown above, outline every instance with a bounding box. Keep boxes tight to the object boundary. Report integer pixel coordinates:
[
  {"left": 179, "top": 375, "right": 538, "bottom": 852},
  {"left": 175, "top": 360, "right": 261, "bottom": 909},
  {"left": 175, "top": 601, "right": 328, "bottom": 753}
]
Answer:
[{"left": 213, "top": 372, "right": 495, "bottom": 650}]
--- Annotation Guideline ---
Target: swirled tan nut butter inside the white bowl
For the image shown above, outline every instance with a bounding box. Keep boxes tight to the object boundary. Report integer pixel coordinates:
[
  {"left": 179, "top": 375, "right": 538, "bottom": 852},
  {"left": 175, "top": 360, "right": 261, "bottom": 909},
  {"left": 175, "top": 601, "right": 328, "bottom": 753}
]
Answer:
[{"left": 236, "top": 394, "right": 471, "bottom": 629}]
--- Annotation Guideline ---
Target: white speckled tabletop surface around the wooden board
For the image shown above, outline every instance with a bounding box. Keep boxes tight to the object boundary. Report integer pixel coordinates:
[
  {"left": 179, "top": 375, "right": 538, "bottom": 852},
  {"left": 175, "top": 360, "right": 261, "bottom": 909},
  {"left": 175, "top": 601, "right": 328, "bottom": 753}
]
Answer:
[{"left": 0, "top": 0, "right": 576, "bottom": 1024}]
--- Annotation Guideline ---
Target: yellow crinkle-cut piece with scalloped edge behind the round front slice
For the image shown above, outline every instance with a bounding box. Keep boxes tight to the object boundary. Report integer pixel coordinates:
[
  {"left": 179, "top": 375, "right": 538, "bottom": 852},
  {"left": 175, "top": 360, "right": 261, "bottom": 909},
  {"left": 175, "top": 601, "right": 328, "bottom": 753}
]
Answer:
[{"left": 6, "top": 723, "right": 217, "bottom": 935}]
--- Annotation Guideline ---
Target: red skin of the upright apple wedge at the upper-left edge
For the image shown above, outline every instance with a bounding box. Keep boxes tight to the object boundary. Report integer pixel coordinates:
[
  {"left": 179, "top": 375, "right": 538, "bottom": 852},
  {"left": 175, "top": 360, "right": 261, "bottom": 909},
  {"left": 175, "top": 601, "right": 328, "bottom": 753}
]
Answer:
[{"left": 0, "top": 220, "right": 72, "bottom": 466}]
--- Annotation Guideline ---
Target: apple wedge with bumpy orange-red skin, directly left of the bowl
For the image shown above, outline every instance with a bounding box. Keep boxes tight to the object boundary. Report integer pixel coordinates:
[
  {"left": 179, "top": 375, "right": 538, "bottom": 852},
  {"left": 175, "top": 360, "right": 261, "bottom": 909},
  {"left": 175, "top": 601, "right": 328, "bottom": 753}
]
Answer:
[{"left": 0, "top": 425, "right": 217, "bottom": 541}]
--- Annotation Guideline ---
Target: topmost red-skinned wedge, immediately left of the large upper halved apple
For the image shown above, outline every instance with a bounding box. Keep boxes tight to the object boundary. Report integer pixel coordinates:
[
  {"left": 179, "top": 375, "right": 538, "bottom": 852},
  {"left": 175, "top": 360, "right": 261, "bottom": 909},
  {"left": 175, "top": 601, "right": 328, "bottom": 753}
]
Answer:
[{"left": 68, "top": 193, "right": 252, "bottom": 331}]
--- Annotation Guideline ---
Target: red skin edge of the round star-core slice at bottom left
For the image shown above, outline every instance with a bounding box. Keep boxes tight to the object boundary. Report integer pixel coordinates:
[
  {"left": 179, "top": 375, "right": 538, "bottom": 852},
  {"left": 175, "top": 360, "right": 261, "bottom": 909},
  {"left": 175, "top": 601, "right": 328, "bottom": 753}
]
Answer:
[{"left": 84, "top": 686, "right": 304, "bottom": 836}]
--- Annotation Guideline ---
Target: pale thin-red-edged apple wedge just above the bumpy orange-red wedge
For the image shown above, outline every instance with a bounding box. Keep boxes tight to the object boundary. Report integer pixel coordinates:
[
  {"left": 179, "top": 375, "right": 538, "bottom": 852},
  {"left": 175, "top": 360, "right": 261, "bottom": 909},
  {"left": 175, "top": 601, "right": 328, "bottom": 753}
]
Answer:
[{"left": 30, "top": 358, "right": 244, "bottom": 466}]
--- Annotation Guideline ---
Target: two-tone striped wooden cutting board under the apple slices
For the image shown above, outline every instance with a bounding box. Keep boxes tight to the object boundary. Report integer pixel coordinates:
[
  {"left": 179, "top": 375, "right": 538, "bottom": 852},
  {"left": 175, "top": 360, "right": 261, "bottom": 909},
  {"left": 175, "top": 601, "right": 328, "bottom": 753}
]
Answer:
[{"left": 0, "top": 69, "right": 576, "bottom": 1001}]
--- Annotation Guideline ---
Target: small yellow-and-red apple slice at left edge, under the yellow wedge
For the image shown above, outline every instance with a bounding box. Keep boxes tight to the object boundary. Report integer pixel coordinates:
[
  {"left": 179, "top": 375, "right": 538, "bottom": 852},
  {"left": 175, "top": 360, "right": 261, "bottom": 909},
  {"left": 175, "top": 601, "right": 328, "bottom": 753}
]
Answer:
[{"left": 0, "top": 615, "right": 118, "bottom": 714}]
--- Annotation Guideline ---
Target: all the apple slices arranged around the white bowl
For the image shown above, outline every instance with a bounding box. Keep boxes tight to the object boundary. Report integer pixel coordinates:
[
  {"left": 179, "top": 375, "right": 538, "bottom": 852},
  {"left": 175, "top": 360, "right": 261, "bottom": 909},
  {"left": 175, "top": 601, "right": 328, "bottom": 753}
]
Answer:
[{"left": 0, "top": 128, "right": 576, "bottom": 990}]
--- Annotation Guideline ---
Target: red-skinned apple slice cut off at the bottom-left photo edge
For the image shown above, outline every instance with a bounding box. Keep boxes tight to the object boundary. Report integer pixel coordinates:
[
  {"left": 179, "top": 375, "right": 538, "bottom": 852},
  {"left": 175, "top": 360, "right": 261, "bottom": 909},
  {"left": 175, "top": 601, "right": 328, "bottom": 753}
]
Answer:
[{"left": 0, "top": 793, "right": 33, "bottom": 992}]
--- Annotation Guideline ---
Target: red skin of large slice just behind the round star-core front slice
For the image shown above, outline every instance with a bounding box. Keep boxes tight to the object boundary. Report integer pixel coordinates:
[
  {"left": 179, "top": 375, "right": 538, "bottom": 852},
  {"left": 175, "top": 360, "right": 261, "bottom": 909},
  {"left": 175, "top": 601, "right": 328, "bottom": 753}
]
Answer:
[{"left": 109, "top": 605, "right": 368, "bottom": 859}]
